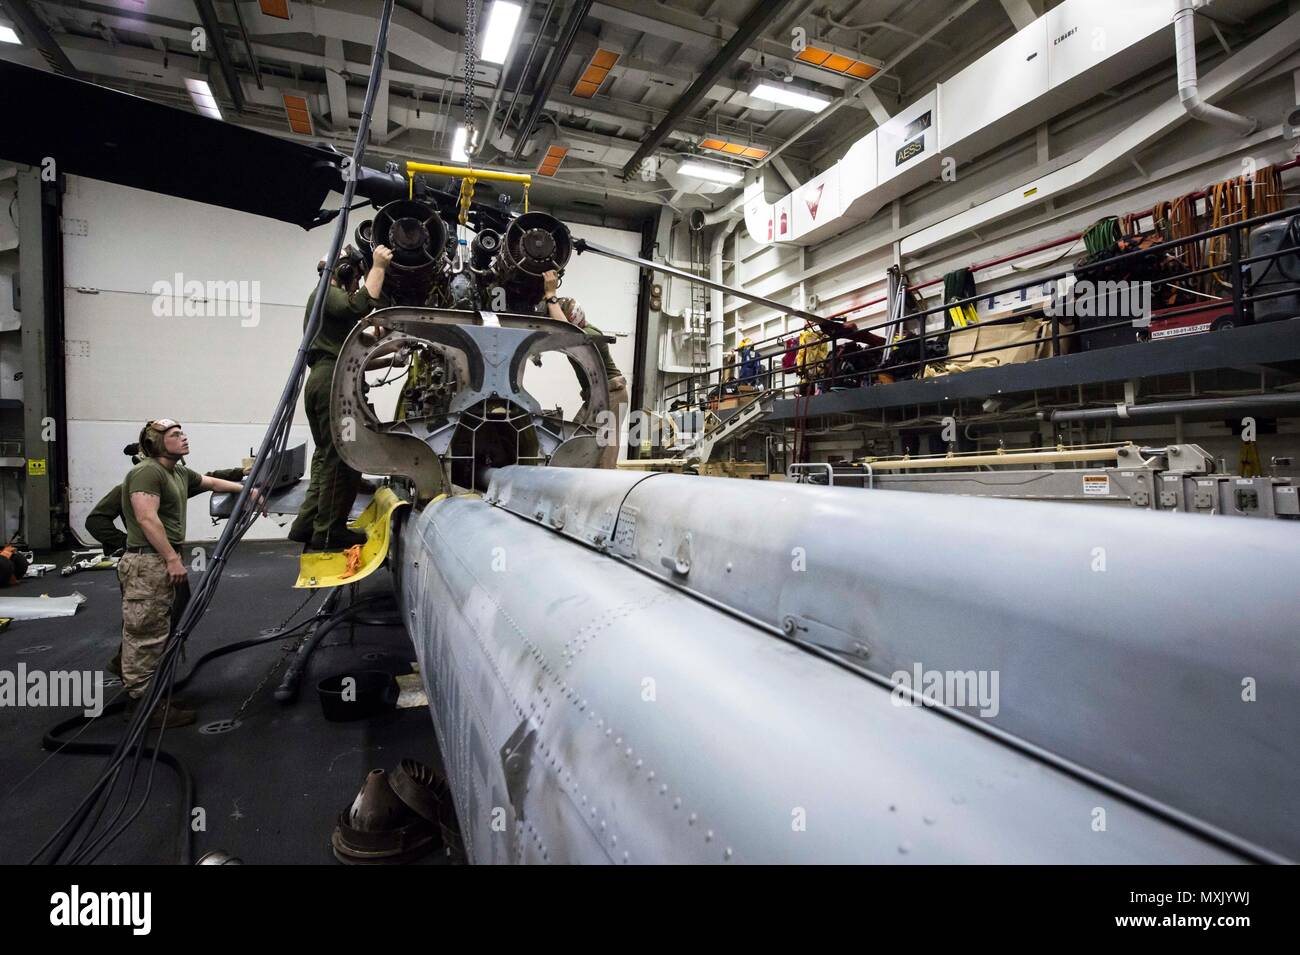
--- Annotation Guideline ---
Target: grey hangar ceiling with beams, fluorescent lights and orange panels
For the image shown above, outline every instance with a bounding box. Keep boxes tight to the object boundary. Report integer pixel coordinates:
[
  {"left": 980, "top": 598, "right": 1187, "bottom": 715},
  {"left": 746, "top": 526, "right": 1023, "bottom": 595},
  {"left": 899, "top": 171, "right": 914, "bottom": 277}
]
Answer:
[{"left": 0, "top": 0, "right": 1274, "bottom": 226}]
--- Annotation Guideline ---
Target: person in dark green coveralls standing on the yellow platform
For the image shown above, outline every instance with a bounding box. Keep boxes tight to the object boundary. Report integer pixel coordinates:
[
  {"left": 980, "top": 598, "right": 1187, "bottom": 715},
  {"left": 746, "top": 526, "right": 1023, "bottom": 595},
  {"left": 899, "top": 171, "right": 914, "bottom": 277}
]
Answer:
[{"left": 289, "top": 246, "right": 393, "bottom": 550}]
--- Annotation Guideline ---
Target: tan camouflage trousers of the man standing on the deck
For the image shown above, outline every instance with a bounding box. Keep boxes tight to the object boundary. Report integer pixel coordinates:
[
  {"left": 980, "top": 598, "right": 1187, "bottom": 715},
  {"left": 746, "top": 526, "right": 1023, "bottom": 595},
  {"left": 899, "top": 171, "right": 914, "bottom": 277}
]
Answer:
[{"left": 117, "top": 552, "right": 190, "bottom": 699}]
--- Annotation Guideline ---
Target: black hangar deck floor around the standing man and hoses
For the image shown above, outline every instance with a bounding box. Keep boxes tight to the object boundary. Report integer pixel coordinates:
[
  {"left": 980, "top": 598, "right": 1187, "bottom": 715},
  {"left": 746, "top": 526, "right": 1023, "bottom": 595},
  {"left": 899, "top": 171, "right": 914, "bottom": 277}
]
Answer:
[{"left": 0, "top": 542, "right": 441, "bottom": 864}]
